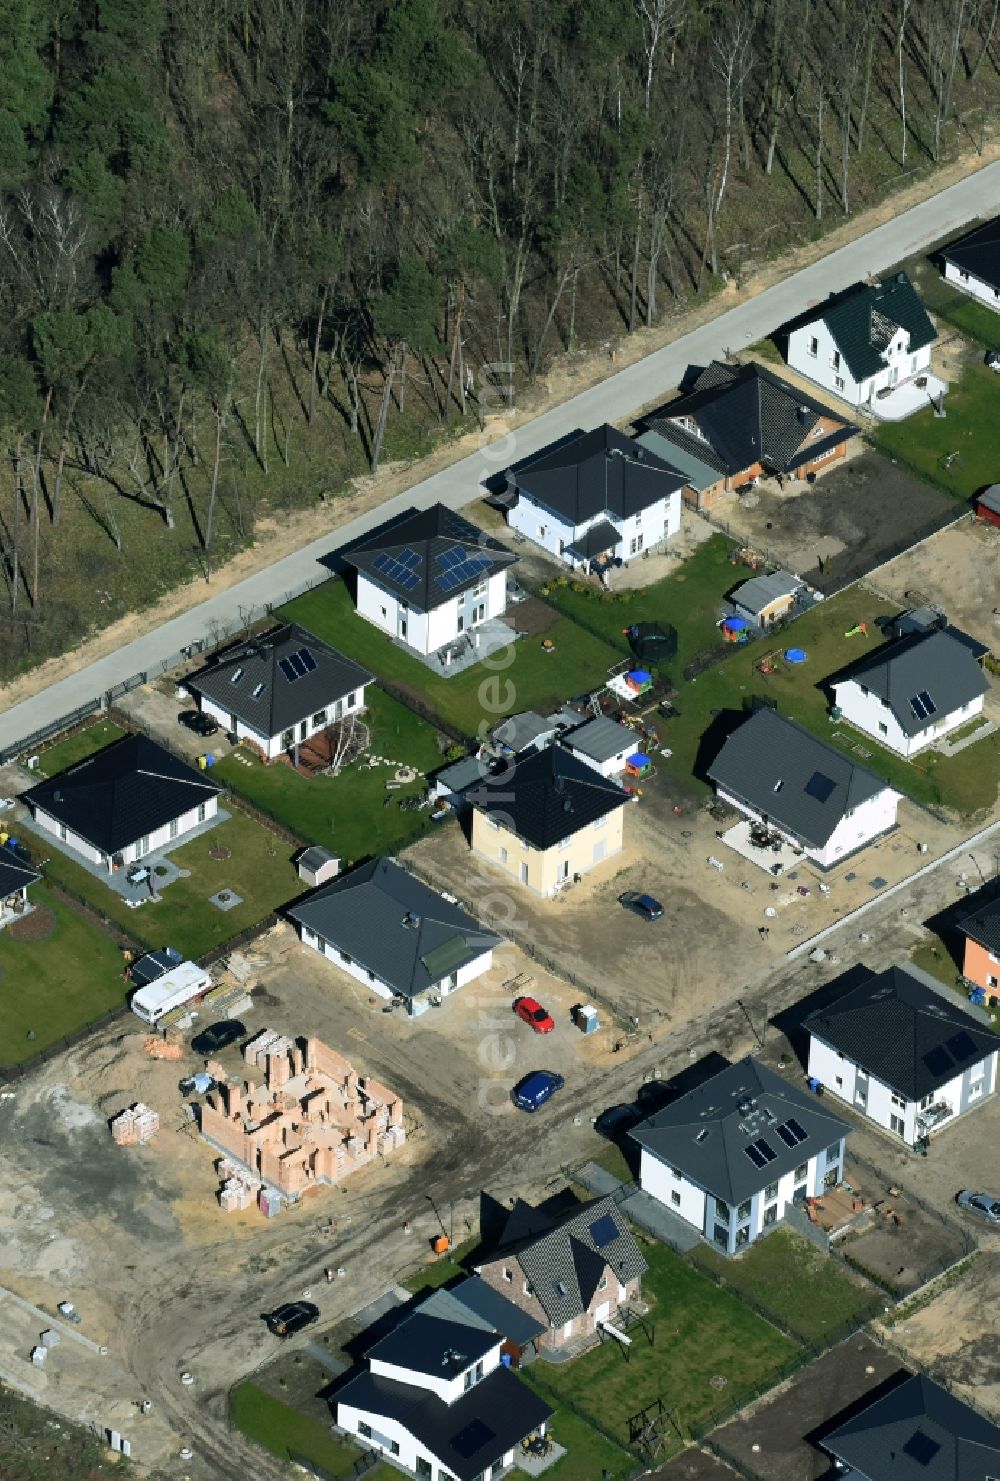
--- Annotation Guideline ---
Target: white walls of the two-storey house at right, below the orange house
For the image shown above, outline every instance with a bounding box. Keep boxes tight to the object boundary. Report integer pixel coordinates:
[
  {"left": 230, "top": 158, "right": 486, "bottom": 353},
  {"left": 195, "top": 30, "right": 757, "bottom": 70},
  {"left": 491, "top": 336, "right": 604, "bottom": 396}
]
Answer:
[{"left": 809, "top": 1034, "right": 997, "bottom": 1146}]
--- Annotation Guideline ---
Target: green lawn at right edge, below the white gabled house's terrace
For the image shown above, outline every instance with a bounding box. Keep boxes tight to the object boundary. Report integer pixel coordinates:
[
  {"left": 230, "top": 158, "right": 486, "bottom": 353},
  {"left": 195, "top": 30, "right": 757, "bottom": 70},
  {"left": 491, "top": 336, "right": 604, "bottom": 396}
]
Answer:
[{"left": 873, "top": 359, "right": 1000, "bottom": 501}]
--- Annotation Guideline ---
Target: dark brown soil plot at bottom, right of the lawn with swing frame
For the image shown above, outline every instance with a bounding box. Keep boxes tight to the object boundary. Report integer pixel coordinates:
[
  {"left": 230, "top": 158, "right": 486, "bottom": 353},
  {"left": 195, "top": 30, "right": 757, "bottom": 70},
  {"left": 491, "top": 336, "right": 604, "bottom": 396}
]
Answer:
[{"left": 708, "top": 1337, "right": 901, "bottom": 1481}]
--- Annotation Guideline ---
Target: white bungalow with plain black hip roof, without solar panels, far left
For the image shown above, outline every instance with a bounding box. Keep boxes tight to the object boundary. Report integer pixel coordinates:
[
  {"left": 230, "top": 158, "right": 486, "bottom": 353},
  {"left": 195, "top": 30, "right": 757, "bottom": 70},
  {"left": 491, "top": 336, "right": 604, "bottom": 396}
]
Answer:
[{"left": 21, "top": 735, "right": 219, "bottom": 872}]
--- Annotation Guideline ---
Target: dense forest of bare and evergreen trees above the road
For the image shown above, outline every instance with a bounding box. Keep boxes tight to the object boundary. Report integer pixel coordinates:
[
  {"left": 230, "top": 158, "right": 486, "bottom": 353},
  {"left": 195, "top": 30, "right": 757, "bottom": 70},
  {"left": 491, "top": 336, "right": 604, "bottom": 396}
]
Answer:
[{"left": 0, "top": 0, "right": 1000, "bottom": 675}]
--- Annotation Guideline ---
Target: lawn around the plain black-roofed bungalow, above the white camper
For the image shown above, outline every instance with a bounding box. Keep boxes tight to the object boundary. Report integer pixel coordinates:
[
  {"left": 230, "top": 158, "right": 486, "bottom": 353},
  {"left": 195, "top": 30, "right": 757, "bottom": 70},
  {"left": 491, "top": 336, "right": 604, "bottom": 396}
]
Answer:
[{"left": 31, "top": 807, "right": 302, "bottom": 957}]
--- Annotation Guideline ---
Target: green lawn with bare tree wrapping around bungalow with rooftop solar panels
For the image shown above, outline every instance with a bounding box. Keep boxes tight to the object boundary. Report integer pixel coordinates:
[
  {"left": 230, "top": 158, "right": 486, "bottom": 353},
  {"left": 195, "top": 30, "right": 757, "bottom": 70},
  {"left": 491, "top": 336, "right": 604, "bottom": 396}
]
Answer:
[{"left": 212, "top": 686, "right": 444, "bottom": 863}]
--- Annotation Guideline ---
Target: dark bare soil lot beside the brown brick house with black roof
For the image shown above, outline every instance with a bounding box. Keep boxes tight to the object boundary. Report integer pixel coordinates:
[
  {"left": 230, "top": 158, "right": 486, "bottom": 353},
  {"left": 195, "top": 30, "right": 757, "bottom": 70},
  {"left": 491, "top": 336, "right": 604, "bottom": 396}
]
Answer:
[{"left": 713, "top": 441, "right": 959, "bottom": 592}]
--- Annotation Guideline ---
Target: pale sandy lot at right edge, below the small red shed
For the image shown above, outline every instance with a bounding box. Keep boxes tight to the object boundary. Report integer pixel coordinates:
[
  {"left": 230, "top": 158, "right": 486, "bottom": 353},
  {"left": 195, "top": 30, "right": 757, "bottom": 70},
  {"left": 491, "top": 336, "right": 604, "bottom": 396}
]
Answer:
[{"left": 873, "top": 518, "right": 1000, "bottom": 653}]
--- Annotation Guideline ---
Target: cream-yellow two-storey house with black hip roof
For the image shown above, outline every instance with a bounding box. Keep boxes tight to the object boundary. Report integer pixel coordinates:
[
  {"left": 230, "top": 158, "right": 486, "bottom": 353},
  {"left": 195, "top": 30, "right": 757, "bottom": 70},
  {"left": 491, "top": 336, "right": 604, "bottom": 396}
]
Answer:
[{"left": 465, "top": 745, "right": 630, "bottom": 895}]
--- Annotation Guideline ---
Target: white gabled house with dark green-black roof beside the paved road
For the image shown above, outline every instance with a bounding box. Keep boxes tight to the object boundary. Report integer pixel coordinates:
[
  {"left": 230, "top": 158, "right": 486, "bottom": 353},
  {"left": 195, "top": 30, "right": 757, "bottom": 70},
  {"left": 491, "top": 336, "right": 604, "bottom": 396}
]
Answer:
[{"left": 787, "top": 273, "right": 938, "bottom": 410}]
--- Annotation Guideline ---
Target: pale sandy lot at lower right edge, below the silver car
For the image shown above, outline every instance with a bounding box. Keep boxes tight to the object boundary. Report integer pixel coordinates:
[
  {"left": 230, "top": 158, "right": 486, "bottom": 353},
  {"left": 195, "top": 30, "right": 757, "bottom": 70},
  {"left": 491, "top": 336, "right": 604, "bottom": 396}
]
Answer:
[{"left": 890, "top": 1251, "right": 1000, "bottom": 1414}]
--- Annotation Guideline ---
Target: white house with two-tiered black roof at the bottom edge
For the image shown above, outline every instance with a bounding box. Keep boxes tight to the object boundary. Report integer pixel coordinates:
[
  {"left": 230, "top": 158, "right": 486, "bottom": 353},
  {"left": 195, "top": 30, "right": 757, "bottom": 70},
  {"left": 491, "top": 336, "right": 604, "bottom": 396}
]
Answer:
[{"left": 330, "top": 1306, "right": 553, "bottom": 1481}]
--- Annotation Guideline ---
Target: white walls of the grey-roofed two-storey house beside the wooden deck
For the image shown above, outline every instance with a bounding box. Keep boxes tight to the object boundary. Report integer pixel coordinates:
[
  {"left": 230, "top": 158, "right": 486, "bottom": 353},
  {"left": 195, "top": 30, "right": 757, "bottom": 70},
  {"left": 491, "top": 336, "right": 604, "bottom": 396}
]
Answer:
[{"left": 639, "top": 1137, "right": 844, "bottom": 1254}]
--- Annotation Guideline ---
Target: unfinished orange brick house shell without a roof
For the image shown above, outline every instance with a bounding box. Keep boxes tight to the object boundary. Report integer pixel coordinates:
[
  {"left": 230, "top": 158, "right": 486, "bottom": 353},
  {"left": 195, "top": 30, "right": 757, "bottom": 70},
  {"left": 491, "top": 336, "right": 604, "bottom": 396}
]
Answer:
[{"left": 201, "top": 1031, "right": 406, "bottom": 1200}]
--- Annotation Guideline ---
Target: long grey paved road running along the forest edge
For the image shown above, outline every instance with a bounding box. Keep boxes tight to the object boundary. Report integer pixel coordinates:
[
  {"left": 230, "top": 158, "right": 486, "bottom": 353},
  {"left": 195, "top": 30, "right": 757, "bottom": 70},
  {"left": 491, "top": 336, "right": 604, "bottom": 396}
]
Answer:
[{"left": 0, "top": 163, "right": 1000, "bottom": 748}]
